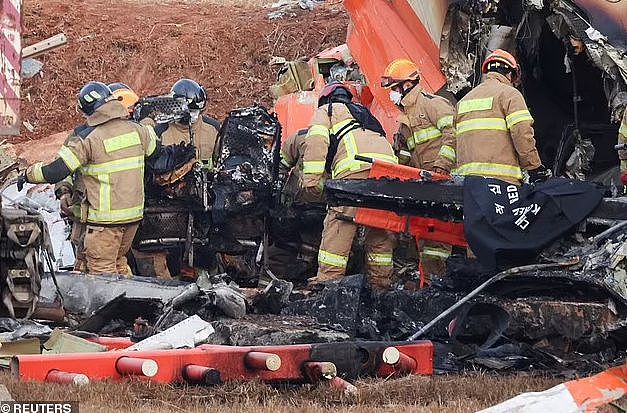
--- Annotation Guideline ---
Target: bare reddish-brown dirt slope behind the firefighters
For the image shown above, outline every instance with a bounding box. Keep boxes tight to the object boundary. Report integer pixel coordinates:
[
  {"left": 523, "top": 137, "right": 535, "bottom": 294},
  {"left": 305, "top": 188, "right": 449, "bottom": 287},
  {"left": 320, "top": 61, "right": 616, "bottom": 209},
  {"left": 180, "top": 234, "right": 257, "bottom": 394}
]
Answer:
[{"left": 17, "top": 0, "right": 348, "bottom": 143}]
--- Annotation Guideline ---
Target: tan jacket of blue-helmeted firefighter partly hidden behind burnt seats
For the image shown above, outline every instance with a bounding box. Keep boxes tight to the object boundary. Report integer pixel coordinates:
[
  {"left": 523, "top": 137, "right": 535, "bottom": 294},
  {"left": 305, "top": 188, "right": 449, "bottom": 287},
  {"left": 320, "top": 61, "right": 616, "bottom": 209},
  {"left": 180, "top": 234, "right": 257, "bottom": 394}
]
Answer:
[{"left": 155, "top": 115, "right": 220, "bottom": 169}]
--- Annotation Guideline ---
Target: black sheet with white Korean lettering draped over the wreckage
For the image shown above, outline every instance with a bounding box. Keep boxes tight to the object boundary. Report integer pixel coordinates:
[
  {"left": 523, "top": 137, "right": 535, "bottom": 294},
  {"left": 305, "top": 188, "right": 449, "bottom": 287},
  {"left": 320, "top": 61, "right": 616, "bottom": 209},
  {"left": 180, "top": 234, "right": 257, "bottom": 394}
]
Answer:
[{"left": 464, "top": 176, "right": 602, "bottom": 270}]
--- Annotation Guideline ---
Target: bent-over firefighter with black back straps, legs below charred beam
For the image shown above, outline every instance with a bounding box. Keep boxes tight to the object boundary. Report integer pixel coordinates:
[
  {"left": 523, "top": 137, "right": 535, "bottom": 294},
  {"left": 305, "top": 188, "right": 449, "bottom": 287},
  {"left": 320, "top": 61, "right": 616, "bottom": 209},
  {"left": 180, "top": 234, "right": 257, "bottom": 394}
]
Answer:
[{"left": 303, "top": 82, "right": 397, "bottom": 289}]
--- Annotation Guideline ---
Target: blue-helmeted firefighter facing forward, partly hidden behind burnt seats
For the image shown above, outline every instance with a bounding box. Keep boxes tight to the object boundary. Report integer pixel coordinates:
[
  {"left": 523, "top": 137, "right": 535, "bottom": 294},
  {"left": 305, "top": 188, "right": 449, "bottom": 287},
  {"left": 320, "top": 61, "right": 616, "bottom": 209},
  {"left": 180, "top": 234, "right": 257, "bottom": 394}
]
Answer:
[{"left": 140, "top": 79, "right": 220, "bottom": 279}]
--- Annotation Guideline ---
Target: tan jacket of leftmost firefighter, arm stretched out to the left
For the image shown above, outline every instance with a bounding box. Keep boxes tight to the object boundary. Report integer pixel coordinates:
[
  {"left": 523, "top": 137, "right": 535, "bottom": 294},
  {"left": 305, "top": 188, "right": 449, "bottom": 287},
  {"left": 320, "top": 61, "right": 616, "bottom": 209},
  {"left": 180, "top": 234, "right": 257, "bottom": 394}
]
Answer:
[{"left": 26, "top": 101, "right": 157, "bottom": 225}]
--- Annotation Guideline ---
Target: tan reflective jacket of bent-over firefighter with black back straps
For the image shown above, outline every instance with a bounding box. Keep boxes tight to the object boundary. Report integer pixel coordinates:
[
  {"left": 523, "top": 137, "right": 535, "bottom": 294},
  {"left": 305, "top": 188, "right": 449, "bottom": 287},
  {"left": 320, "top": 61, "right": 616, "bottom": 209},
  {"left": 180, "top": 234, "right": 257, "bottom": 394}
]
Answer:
[{"left": 303, "top": 103, "right": 398, "bottom": 196}]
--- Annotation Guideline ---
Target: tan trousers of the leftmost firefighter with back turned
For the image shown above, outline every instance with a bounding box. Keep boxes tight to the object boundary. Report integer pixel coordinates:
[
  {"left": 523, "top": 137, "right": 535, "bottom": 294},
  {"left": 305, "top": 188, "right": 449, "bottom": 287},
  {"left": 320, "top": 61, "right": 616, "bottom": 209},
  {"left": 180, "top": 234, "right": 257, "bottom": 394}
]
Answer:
[{"left": 85, "top": 223, "right": 139, "bottom": 276}]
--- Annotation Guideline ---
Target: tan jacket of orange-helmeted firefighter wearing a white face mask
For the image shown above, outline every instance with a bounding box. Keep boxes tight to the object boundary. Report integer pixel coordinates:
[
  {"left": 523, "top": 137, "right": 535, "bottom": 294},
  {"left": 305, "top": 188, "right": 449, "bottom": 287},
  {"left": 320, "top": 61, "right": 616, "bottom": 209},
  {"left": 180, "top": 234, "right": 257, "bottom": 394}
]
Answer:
[{"left": 395, "top": 86, "right": 456, "bottom": 172}]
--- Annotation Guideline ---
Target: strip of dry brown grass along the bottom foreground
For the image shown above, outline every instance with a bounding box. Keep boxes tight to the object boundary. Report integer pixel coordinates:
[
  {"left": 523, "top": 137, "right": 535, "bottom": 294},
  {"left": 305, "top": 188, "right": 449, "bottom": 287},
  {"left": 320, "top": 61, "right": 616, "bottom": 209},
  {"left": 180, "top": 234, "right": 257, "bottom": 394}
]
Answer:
[{"left": 0, "top": 374, "right": 559, "bottom": 413}]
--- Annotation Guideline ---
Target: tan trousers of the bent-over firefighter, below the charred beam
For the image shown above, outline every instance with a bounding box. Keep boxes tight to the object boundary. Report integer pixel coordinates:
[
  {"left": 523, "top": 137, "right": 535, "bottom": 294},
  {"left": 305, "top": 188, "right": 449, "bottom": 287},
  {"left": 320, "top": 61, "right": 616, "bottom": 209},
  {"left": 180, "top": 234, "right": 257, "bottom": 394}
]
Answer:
[{"left": 311, "top": 206, "right": 394, "bottom": 289}]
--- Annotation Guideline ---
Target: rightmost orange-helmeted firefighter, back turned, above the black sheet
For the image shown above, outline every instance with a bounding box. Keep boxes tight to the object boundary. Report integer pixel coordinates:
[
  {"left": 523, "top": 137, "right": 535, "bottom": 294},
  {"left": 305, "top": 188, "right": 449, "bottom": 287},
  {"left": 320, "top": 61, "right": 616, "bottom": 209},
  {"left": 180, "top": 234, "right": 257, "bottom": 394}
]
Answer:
[{"left": 454, "top": 49, "right": 550, "bottom": 185}]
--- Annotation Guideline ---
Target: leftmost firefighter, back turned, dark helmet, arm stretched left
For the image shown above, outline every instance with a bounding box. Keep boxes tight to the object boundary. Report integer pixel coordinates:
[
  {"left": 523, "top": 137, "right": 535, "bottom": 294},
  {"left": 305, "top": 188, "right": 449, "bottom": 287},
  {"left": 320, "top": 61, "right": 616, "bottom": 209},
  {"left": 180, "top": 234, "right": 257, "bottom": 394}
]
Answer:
[{"left": 26, "top": 82, "right": 157, "bottom": 275}]
